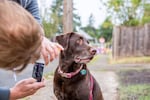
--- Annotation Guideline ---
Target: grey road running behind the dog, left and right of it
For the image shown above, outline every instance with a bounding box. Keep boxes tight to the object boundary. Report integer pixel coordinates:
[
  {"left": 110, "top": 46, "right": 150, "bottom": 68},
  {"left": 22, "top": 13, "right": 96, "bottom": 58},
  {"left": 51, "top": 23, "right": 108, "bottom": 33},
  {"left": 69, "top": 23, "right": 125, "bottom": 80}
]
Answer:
[{"left": 0, "top": 55, "right": 150, "bottom": 87}]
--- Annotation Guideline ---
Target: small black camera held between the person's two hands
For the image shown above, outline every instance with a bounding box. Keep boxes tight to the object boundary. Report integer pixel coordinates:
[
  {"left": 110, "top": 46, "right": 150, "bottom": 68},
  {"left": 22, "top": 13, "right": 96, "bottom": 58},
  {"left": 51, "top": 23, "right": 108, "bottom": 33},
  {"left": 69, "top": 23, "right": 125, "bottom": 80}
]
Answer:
[{"left": 32, "top": 62, "right": 45, "bottom": 82}]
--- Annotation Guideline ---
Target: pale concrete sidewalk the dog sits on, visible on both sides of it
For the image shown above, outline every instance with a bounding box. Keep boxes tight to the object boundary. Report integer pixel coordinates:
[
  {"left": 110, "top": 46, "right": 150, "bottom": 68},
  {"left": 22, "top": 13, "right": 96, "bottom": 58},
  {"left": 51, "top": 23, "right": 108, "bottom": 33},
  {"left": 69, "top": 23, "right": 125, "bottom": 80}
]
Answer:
[{"left": 26, "top": 55, "right": 118, "bottom": 100}]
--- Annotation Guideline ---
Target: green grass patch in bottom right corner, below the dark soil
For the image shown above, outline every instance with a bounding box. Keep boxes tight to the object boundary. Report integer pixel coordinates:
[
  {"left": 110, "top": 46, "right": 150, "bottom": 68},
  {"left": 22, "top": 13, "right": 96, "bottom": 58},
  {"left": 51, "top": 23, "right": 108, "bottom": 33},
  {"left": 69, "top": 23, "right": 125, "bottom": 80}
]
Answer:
[{"left": 119, "top": 84, "right": 150, "bottom": 100}]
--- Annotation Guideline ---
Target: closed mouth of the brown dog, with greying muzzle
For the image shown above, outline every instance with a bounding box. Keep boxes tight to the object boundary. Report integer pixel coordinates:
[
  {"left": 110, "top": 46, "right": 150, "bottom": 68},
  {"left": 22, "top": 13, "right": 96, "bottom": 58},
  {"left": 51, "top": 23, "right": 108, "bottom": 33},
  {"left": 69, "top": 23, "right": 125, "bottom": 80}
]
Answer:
[{"left": 74, "top": 56, "right": 93, "bottom": 63}]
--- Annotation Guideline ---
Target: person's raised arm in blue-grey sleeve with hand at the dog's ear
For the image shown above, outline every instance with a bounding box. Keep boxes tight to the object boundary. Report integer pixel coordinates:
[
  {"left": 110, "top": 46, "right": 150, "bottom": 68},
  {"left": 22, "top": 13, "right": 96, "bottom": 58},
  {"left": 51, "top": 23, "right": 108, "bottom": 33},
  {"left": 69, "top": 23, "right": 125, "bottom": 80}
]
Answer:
[{"left": 25, "top": 0, "right": 63, "bottom": 65}]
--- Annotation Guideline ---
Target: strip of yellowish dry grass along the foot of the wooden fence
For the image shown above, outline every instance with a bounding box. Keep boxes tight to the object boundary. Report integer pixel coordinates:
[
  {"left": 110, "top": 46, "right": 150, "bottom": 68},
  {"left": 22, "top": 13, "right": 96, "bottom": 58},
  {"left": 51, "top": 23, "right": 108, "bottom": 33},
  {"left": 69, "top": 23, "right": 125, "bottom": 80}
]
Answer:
[{"left": 109, "top": 57, "right": 150, "bottom": 64}]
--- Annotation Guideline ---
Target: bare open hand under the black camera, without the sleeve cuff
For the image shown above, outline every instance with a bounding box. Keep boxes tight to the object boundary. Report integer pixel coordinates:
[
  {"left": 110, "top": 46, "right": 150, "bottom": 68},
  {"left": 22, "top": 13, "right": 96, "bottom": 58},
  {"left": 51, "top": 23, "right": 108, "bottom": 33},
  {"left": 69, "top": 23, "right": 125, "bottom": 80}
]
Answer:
[{"left": 10, "top": 78, "right": 45, "bottom": 100}]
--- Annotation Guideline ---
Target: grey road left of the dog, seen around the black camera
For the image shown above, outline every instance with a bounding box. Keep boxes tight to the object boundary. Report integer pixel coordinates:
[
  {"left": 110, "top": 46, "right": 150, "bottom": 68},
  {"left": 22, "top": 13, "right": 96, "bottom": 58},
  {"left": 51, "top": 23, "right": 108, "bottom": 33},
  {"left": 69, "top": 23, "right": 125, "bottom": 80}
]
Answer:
[{"left": 0, "top": 59, "right": 58, "bottom": 87}]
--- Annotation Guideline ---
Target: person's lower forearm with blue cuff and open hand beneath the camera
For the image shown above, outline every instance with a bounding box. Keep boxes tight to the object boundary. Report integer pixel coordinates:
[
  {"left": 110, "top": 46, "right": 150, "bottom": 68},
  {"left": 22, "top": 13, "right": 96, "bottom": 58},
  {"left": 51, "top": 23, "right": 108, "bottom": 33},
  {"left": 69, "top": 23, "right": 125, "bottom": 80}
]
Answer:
[{"left": 0, "top": 78, "right": 45, "bottom": 100}]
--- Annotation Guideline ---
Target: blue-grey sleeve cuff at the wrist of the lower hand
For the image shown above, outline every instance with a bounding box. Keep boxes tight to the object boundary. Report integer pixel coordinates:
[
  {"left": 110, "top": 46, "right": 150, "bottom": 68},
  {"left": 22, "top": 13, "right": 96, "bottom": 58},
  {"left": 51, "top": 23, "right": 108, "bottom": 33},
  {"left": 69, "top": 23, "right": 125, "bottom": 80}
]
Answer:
[{"left": 0, "top": 87, "right": 10, "bottom": 100}]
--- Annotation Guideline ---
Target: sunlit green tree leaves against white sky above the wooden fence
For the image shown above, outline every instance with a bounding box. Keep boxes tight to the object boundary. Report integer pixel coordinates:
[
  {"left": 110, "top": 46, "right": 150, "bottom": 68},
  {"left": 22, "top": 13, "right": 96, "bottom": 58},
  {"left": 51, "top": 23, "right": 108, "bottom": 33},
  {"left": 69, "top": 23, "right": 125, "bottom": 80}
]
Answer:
[{"left": 101, "top": 0, "right": 144, "bottom": 26}]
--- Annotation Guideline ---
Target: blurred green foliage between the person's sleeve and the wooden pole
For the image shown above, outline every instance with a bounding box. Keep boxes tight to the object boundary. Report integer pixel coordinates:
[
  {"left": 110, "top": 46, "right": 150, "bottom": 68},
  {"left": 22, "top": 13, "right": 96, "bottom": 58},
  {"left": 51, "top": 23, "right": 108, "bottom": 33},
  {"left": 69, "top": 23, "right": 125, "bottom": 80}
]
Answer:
[{"left": 42, "top": 0, "right": 63, "bottom": 38}]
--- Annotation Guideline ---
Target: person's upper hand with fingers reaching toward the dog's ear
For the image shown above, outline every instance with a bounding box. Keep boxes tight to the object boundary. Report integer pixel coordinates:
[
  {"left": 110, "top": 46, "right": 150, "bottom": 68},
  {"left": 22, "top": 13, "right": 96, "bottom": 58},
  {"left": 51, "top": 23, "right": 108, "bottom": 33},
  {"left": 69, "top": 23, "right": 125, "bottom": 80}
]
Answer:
[{"left": 41, "top": 37, "right": 64, "bottom": 65}]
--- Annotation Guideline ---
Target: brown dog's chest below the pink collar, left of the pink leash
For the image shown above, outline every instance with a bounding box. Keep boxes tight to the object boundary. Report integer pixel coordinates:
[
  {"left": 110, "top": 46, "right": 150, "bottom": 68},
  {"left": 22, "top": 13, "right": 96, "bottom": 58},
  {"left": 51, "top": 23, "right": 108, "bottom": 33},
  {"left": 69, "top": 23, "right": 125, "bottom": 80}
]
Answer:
[{"left": 61, "top": 77, "right": 90, "bottom": 100}]
